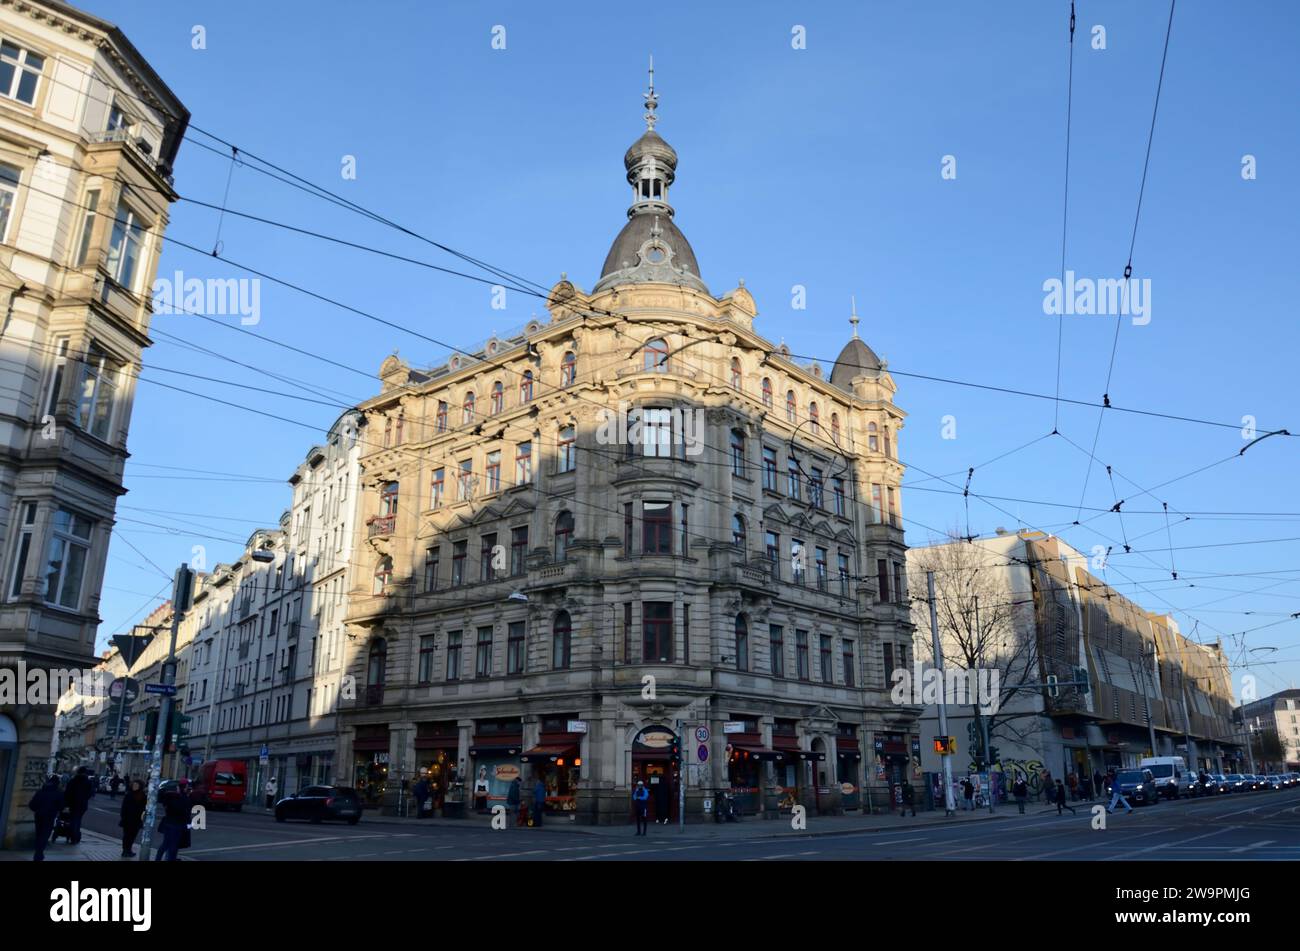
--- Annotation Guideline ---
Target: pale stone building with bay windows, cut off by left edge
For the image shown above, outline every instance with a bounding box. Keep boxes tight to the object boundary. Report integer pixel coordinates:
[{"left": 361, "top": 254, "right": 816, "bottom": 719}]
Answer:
[{"left": 0, "top": 0, "right": 189, "bottom": 847}]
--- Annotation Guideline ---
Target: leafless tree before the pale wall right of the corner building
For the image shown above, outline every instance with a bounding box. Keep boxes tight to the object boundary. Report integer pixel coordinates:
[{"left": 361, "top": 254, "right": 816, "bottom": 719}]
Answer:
[{"left": 907, "top": 533, "right": 1039, "bottom": 768}]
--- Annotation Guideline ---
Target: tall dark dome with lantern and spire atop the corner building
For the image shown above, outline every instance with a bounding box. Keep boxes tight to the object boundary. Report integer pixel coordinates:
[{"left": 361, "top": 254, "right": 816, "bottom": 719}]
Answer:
[{"left": 592, "top": 58, "right": 709, "bottom": 294}]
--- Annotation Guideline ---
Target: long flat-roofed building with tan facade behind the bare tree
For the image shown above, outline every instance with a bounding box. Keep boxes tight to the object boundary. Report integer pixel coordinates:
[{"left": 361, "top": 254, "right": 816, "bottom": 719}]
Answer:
[{"left": 904, "top": 531, "right": 1239, "bottom": 791}]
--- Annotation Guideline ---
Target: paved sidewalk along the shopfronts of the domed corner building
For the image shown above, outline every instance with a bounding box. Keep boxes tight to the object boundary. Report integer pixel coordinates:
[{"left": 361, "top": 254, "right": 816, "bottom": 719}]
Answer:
[{"left": 361, "top": 804, "right": 1024, "bottom": 839}]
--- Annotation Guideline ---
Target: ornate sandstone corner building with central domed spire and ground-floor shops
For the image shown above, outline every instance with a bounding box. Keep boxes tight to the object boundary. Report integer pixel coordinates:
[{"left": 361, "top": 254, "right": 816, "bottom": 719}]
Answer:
[{"left": 338, "top": 77, "right": 919, "bottom": 822}]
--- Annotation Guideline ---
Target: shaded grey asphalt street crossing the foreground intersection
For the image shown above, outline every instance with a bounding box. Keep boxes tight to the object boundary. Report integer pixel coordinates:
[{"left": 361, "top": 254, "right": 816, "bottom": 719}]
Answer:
[{"left": 86, "top": 789, "right": 1300, "bottom": 863}]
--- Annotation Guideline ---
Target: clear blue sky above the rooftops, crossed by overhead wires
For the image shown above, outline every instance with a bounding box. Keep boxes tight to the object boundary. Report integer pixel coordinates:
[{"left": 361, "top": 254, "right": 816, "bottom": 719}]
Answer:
[{"left": 91, "top": 0, "right": 1300, "bottom": 695}]
